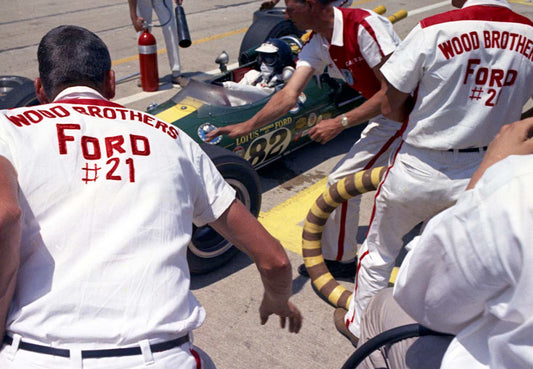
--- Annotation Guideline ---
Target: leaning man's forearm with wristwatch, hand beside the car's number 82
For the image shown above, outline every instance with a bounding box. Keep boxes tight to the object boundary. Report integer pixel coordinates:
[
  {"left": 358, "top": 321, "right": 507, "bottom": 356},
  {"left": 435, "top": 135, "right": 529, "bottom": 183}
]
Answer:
[{"left": 309, "top": 56, "right": 400, "bottom": 144}]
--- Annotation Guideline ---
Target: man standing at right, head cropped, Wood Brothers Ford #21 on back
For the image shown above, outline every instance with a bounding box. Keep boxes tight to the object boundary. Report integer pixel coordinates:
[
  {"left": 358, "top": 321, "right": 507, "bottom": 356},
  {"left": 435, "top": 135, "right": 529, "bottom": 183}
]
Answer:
[{"left": 345, "top": 0, "right": 533, "bottom": 336}]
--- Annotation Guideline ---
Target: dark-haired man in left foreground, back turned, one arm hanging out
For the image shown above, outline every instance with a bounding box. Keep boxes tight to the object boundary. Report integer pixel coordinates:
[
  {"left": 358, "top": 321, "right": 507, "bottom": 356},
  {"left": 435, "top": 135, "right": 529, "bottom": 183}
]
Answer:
[{"left": 0, "top": 26, "right": 301, "bottom": 369}]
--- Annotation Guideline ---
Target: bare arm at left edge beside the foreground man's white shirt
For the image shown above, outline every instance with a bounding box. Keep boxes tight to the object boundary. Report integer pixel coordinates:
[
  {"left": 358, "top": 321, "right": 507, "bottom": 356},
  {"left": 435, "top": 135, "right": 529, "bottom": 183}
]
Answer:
[{"left": 0, "top": 156, "right": 22, "bottom": 337}]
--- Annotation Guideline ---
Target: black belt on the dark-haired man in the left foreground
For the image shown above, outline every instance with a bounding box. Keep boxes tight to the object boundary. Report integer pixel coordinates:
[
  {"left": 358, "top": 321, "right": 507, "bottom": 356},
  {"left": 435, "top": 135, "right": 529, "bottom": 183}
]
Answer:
[{"left": 4, "top": 335, "right": 189, "bottom": 359}]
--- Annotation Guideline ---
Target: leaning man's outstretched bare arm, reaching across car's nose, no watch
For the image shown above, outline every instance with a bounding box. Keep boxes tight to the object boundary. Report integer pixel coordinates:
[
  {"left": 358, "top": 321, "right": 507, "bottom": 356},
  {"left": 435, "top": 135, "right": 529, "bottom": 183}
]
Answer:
[{"left": 207, "top": 66, "right": 314, "bottom": 141}]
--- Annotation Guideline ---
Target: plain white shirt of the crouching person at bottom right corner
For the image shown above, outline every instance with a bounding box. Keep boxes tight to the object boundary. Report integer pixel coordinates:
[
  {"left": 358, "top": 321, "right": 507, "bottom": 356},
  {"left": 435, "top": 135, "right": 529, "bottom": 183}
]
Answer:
[{"left": 394, "top": 155, "right": 533, "bottom": 369}]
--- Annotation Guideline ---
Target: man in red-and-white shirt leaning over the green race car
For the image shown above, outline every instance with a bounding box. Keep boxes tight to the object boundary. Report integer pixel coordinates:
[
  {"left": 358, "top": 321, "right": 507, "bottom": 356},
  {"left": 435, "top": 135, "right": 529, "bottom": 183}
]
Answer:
[{"left": 207, "top": 0, "right": 400, "bottom": 294}]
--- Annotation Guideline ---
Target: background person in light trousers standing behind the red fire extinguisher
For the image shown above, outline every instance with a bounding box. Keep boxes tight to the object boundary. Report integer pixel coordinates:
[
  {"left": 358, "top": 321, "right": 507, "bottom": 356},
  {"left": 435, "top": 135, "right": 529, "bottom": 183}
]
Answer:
[{"left": 128, "top": 0, "right": 183, "bottom": 84}]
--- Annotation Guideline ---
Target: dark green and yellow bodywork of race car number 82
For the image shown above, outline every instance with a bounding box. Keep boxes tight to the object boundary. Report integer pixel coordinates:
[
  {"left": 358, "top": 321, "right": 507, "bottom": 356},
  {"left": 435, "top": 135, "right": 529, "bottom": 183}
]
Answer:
[{"left": 148, "top": 64, "right": 364, "bottom": 168}]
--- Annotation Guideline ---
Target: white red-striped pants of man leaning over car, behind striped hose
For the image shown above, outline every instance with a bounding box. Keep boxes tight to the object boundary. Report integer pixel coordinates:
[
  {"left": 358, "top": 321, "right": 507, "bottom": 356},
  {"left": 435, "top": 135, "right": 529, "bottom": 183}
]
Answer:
[{"left": 322, "top": 116, "right": 401, "bottom": 260}]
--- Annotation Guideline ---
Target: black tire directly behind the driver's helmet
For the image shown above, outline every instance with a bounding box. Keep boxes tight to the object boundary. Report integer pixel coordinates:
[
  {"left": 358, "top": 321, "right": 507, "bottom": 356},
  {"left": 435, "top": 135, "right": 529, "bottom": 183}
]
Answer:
[{"left": 239, "top": 9, "right": 303, "bottom": 65}]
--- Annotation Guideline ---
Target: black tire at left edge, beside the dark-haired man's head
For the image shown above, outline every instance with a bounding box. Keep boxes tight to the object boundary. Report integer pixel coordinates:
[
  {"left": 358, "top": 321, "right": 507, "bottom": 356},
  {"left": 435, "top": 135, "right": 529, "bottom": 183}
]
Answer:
[{"left": 0, "top": 76, "right": 39, "bottom": 109}]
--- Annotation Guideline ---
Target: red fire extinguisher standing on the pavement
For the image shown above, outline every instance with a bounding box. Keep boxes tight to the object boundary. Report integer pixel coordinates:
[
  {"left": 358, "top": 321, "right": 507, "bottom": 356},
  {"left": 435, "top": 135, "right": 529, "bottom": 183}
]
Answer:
[{"left": 139, "top": 25, "right": 159, "bottom": 91}]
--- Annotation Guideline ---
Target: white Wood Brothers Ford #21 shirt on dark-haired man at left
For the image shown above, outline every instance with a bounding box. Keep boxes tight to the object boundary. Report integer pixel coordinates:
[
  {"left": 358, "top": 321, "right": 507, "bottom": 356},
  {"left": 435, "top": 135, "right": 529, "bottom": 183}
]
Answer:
[{"left": 0, "top": 87, "right": 235, "bottom": 350}]
